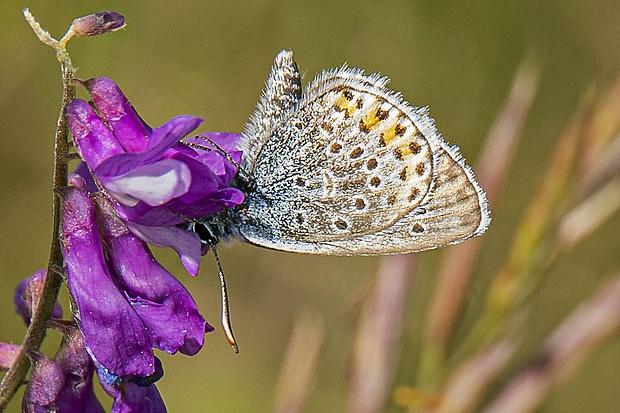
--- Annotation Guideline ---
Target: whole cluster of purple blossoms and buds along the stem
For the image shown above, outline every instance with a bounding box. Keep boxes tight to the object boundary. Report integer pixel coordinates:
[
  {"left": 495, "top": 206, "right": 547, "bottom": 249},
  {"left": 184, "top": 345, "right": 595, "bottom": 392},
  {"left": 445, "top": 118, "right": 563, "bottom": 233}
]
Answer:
[{"left": 0, "top": 77, "right": 244, "bottom": 412}]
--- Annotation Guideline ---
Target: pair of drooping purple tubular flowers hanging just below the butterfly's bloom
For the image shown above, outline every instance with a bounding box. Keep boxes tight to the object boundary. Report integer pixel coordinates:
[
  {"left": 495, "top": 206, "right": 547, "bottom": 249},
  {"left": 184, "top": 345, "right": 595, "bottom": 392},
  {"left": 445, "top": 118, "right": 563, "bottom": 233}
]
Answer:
[{"left": 62, "top": 175, "right": 212, "bottom": 384}]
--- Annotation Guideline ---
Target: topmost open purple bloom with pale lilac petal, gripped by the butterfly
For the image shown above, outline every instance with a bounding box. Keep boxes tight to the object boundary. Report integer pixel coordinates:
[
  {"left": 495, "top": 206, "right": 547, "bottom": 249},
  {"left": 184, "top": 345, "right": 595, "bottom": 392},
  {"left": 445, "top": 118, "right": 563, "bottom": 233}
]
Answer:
[{"left": 66, "top": 77, "right": 244, "bottom": 275}]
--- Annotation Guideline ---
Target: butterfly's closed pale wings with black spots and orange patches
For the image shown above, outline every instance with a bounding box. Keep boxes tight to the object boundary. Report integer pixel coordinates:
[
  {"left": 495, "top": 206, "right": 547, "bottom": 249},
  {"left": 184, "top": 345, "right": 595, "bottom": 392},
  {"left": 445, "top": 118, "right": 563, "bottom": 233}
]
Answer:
[{"left": 238, "top": 52, "right": 489, "bottom": 255}]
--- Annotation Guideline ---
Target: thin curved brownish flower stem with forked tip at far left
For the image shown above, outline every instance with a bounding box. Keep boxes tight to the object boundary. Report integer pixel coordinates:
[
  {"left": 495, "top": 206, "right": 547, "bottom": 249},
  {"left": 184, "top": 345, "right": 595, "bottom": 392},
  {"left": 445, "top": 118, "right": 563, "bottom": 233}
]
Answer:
[{"left": 0, "top": 9, "right": 75, "bottom": 412}]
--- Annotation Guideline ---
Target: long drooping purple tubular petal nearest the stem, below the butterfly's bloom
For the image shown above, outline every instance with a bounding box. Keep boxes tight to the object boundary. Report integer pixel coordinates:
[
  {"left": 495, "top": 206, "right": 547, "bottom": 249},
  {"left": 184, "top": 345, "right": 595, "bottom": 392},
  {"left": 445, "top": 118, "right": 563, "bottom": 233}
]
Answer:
[{"left": 61, "top": 187, "right": 153, "bottom": 376}]
